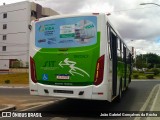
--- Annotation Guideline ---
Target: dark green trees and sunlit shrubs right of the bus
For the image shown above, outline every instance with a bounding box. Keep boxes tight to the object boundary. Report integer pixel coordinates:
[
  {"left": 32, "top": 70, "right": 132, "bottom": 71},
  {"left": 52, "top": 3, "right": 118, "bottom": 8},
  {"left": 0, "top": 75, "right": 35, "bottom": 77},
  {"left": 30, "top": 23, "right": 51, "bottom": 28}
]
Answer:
[{"left": 132, "top": 53, "right": 160, "bottom": 79}]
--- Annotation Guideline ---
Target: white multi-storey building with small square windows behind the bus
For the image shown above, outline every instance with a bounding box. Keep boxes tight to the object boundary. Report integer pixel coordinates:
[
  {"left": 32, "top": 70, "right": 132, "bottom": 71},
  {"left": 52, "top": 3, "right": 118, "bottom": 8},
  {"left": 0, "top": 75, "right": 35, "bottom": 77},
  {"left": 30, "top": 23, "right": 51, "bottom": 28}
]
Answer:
[{"left": 0, "top": 1, "right": 58, "bottom": 71}]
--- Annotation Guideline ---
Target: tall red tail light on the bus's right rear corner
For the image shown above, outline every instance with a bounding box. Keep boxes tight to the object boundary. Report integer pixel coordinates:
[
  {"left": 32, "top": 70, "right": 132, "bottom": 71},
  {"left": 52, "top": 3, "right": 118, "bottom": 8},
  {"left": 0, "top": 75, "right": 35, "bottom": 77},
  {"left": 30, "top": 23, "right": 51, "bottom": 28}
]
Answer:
[{"left": 94, "top": 55, "right": 104, "bottom": 85}]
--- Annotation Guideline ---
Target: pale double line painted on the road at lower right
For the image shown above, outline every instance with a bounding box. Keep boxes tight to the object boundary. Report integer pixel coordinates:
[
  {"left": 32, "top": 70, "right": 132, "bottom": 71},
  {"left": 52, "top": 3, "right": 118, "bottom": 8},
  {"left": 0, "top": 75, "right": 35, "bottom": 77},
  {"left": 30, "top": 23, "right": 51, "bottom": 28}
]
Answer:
[{"left": 134, "top": 84, "right": 160, "bottom": 120}]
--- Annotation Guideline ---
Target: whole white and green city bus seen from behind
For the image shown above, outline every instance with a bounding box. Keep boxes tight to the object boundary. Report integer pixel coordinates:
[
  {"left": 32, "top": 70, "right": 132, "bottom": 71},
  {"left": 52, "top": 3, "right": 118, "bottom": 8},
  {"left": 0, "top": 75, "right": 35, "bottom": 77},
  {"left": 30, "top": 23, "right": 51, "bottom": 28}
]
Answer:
[{"left": 29, "top": 13, "right": 132, "bottom": 102}]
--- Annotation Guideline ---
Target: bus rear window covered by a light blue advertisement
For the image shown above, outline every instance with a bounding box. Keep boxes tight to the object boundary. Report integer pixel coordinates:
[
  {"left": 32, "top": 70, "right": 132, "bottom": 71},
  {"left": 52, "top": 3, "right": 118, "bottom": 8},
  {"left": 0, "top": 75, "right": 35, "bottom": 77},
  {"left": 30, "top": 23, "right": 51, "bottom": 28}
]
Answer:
[{"left": 35, "top": 16, "right": 97, "bottom": 48}]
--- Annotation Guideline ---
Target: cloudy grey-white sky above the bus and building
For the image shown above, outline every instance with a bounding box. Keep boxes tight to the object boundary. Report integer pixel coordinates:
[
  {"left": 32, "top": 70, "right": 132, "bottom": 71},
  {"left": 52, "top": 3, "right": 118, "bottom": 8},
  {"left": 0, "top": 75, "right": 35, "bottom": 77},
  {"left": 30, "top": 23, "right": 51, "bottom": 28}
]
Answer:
[{"left": 0, "top": 0, "right": 160, "bottom": 55}]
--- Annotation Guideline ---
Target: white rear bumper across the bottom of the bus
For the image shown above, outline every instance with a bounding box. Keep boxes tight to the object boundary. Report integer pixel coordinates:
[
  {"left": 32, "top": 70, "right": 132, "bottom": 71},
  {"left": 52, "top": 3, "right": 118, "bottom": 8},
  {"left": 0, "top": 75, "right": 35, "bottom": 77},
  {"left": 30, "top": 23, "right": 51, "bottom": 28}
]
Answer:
[{"left": 30, "top": 83, "right": 110, "bottom": 101}]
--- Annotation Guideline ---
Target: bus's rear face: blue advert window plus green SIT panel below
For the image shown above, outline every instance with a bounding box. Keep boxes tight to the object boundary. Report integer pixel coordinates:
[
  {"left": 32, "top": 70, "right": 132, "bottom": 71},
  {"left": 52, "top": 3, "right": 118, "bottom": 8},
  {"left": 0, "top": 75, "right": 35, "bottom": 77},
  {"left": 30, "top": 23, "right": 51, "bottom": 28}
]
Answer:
[{"left": 31, "top": 16, "right": 100, "bottom": 86}]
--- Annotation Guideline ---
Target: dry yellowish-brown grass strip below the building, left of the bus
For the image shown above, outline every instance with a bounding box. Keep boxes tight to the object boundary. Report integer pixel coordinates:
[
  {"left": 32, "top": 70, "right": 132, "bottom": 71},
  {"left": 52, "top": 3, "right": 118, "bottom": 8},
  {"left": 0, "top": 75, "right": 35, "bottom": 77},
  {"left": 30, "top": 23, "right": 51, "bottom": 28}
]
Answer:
[{"left": 0, "top": 73, "right": 29, "bottom": 84}]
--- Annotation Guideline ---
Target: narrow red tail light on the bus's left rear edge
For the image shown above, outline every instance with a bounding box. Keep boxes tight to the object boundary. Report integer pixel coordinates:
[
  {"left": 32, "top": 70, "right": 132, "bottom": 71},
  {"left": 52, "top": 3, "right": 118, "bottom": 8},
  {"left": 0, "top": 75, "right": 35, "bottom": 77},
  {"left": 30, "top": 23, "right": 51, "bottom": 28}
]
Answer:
[{"left": 30, "top": 57, "right": 37, "bottom": 83}]
